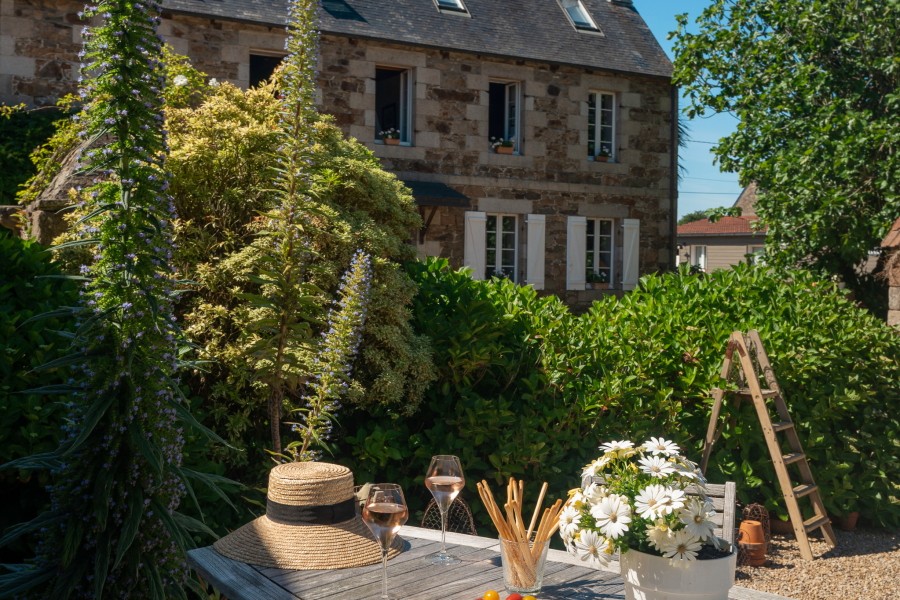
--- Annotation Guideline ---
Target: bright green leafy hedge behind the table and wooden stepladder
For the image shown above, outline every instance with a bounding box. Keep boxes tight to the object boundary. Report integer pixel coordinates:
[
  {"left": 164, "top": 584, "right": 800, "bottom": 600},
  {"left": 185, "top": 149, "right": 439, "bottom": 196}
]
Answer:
[{"left": 338, "top": 260, "right": 900, "bottom": 525}]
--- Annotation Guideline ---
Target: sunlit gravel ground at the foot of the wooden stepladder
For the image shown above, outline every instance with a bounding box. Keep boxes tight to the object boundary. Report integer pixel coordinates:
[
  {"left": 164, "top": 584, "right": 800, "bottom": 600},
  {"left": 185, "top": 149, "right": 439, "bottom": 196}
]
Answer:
[{"left": 735, "top": 529, "right": 900, "bottom": 600}]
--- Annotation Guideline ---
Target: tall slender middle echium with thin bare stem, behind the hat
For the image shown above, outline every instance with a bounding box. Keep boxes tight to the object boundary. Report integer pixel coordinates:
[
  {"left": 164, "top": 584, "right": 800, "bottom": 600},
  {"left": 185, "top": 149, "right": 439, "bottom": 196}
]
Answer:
[{"left": 239, "top": 0, "right": 370, "bottom": 457}]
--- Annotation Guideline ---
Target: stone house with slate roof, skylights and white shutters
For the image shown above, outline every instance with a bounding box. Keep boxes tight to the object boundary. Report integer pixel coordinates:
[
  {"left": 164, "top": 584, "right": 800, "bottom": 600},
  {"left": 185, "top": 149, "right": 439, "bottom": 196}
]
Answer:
[{"left": 0, "top": 0, "right": 677, "bottom": 305}]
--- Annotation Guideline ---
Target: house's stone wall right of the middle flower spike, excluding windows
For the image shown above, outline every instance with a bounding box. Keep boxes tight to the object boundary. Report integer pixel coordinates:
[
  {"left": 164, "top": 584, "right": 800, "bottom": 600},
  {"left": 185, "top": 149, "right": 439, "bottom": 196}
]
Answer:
[{"left": 320, "top": 35, "right": 674, "bottom": 304}]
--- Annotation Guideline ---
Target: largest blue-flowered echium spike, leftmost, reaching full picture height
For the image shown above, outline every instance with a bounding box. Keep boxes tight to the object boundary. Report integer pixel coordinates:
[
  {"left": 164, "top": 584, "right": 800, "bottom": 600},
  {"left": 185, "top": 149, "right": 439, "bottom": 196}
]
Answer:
[{"left": 0, "top": 0, "right": 217, "bottom": 598}]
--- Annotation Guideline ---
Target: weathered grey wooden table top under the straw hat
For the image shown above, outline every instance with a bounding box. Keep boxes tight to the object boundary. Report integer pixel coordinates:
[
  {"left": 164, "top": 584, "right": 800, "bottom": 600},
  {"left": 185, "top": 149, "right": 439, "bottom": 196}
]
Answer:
[{"left": 188, "top": 527, "right": 777, "bottom": 600}]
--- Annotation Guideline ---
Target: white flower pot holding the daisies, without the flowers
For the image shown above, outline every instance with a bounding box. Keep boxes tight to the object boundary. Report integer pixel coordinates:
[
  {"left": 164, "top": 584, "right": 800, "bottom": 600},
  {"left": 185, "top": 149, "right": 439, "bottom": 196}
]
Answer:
[{"left": 619, "top": 550, "right": 737, "bottom": 600}]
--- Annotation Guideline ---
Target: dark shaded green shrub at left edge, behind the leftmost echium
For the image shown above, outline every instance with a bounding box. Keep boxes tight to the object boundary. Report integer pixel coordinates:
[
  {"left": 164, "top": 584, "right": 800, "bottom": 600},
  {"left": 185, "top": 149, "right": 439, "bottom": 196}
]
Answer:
[{"left": 0, "top": 229, "right": 76, "bottom": 562}]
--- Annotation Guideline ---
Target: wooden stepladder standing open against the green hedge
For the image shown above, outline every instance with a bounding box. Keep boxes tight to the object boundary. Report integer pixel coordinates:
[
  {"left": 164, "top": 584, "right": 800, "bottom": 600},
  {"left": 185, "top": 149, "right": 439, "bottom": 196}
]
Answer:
[{"left": 700, "top": 330, "right": 837, "bottom": 560}]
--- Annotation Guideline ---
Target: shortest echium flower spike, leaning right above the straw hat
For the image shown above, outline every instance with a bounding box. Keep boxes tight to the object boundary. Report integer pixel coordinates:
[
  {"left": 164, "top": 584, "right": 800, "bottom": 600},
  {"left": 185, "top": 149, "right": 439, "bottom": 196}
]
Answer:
[{"left": 286, "top": 251, "right": 372, "bottom": 461}]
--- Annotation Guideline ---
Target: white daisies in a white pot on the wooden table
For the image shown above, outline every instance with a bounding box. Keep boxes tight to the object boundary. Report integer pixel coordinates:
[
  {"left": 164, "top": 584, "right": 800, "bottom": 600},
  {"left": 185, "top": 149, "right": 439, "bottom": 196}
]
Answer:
[{"left": 559, "top": 438, "right": 737, "bottom": 600}]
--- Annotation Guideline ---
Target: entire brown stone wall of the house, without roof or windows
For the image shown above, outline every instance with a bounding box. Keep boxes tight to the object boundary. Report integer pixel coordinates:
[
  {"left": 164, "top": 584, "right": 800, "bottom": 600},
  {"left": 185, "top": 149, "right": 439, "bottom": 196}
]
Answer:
[{"left": 0, "top": 0, "right": 675, "bottom": 303}]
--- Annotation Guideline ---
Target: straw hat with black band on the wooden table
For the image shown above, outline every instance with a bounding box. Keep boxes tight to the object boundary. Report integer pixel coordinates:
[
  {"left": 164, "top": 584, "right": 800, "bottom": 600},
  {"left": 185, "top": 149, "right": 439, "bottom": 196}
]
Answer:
[{"left": 213, "top": 462, "right": 402, "bottom": 569}]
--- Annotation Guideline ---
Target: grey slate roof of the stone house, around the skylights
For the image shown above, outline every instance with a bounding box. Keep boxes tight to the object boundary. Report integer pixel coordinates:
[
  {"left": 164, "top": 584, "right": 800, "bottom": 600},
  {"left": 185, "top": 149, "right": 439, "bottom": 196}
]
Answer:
[{"left": 163, "top": 0, "right": 672, "bottom": 79}]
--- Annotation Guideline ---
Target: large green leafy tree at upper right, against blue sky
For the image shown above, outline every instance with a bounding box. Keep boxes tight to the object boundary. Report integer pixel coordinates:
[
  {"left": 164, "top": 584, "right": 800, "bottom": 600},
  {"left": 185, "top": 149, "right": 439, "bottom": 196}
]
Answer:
[{"left": 673, "top": 0, "right": 900, "bottom": 291}]
